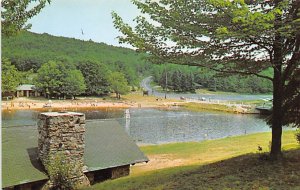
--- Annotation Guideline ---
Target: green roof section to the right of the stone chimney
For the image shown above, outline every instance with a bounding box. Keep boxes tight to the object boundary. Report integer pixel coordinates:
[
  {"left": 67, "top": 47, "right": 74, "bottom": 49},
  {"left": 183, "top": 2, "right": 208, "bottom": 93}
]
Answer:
[{"left": 84, "top": 121, "right": 148, "bottom": 171}]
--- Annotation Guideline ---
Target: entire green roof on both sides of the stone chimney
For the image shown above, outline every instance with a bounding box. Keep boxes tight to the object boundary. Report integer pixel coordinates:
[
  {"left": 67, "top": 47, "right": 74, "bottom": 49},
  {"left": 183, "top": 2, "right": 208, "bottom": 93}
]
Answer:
[{"left": 2, "top": 120, "right": 148, "bottom": 188}]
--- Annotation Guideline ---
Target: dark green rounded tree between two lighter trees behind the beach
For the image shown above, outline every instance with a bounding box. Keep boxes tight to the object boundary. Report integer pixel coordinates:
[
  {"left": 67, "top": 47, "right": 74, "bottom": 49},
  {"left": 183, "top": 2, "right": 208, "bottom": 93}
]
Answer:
[{"left": 78, "top": 61, "right": 109, "bottom": 95}]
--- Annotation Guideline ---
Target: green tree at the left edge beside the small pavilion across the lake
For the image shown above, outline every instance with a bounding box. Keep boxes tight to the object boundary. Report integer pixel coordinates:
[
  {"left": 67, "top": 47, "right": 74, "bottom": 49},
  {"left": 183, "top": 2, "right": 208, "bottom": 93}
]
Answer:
[{"left": 1, "top": 58, "right": 20, "bottom": 93}]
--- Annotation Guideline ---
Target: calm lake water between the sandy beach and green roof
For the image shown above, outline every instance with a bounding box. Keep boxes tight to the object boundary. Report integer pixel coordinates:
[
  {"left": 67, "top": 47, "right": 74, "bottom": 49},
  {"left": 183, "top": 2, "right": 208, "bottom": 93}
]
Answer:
[{"left": 2, "top": 108, "right": 270, "bottom": 144}]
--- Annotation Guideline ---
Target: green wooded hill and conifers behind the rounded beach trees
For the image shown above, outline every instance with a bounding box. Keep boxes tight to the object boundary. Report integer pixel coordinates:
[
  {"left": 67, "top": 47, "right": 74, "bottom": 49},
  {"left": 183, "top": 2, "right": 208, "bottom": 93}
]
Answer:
[{"left": 2, "top": 32, "right": 272, "bottom": 93}]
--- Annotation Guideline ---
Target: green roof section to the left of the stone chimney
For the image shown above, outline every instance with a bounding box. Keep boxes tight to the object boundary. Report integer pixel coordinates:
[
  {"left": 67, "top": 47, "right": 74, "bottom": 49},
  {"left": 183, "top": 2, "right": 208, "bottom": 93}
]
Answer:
[{"left": 2, "top": 127, "right": 48, "bottom": 187}]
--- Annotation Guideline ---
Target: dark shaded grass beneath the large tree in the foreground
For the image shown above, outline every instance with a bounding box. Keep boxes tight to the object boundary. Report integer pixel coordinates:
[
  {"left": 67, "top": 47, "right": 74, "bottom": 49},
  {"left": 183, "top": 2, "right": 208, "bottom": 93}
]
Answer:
[{"left": 91, "top": 149, "right": 300, "bottom": 190}]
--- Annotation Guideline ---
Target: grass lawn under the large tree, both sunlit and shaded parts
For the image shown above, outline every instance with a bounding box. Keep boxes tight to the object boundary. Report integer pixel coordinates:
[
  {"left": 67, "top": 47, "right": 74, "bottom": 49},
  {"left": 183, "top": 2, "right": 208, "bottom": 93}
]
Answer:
[{"left": 85, "top": 131, "right": 300, "bottom": 190}]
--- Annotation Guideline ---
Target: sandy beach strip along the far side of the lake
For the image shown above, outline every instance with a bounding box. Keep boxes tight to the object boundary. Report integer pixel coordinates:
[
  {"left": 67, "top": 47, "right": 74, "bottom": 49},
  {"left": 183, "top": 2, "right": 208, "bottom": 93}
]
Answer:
[{"left": 1, "top": 94, "right": 257, "bottom": 114}]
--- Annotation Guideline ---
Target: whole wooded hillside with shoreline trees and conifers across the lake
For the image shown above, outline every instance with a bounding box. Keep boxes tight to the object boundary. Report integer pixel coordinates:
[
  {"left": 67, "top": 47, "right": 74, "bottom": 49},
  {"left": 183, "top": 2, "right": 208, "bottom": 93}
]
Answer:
[{"left": 2, "top": 32, "right": 272, "bottom": 95}]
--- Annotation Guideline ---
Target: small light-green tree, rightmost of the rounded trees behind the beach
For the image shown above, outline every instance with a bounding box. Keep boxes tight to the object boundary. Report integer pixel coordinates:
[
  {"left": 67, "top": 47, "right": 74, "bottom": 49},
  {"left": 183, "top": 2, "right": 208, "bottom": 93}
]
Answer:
[{"left": 108, "top": 72, "right": 129, "bottom": 99}]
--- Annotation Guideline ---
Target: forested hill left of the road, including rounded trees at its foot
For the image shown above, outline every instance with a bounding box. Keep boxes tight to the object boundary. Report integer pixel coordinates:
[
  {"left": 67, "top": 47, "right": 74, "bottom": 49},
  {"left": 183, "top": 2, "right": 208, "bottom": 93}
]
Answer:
[{"left": 2, "top": 32, "right": 152, "bottom": 98}]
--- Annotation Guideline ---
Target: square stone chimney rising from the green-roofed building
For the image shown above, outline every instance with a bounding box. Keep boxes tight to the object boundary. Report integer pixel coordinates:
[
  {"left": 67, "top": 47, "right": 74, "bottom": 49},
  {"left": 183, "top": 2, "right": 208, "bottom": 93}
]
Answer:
[{"left": 38, "top": 112, "right": 89, "bottom": 186}]
